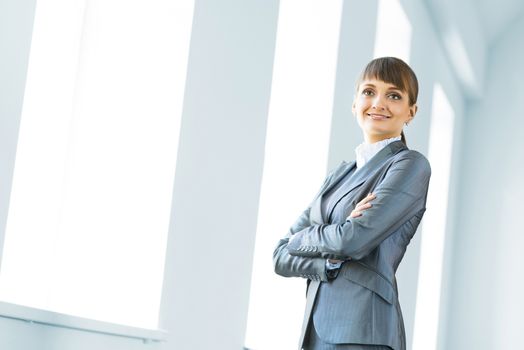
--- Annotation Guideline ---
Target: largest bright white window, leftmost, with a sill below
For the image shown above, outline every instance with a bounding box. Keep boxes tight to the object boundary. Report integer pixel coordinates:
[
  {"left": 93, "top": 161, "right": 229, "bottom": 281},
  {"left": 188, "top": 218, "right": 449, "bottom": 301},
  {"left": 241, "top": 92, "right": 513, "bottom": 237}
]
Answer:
[{"left": 0, "top": 0, "right": 193, "bottom": 328}]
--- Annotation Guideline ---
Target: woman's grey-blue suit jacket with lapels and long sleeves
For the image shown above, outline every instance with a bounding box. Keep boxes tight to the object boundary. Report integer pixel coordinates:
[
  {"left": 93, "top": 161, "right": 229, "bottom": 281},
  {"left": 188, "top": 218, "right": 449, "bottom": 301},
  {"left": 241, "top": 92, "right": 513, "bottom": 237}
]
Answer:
[{"left": 273, "top": 141, "right": 431, "bottom": 350}]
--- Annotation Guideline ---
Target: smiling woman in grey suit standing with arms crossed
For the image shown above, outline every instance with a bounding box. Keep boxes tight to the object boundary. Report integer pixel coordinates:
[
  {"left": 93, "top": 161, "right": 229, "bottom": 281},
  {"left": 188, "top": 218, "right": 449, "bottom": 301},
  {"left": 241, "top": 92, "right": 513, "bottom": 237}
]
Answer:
[{"left": 273, "top": 57, "right": 431, "bottom": 350}]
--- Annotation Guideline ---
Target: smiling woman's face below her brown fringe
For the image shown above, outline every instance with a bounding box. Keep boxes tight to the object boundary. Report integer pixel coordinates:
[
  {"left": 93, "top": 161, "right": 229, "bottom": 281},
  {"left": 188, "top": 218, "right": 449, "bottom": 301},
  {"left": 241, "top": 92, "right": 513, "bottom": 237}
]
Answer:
[{"left": 352, "top": 79, "right": 417, "bottom": 143}]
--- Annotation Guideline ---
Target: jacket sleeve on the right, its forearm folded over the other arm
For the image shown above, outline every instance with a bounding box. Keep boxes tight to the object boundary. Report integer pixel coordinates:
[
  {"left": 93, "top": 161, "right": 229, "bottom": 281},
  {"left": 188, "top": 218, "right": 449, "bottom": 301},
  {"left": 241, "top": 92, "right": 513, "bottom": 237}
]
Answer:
[{"left": 286, "top": 151, "right": 431, "bottom": 260}]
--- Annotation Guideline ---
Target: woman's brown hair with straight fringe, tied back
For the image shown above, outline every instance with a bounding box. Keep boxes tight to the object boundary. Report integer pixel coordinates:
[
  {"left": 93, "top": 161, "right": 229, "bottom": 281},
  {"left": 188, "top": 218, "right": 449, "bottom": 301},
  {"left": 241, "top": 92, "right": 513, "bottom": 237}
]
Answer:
[{"left": 355, "top": 57, "right": 418, "bottom": 144}]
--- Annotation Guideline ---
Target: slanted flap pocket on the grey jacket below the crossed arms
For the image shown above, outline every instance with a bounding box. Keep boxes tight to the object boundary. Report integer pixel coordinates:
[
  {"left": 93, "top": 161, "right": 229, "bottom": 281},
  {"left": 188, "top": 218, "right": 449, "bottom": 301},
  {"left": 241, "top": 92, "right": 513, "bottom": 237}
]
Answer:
[{"left": 341, "top": 263, "right": 396, "bottom": 304}]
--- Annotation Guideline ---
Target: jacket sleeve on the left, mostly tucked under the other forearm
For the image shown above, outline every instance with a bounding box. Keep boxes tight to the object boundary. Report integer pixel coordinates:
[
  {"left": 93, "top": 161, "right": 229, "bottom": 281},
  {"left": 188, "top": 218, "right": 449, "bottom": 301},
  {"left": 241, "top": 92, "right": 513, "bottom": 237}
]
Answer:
[{"left": 273, "top": 163, "right": 344, "bottom": 281}]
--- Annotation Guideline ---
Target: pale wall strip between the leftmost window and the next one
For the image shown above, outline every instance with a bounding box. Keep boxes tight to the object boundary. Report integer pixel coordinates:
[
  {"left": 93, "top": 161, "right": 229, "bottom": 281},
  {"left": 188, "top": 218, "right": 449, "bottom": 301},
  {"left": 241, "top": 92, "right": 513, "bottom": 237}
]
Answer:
[{"left": 156, "top": 0, "right": 278, "bottom": 350}]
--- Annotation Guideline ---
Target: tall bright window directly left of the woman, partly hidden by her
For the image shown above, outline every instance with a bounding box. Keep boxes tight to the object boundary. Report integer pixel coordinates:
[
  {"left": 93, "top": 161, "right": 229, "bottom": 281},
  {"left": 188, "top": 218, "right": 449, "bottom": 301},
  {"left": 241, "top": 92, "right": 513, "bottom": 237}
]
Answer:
[{"left": 246, "top": 0, "right": 342, "bottom": 350}]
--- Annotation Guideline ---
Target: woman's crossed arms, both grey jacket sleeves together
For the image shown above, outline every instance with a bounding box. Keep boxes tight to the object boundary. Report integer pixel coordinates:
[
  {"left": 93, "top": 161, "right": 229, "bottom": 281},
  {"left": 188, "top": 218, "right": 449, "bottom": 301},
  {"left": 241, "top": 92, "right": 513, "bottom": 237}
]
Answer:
[{"left": 273, "top": 151, "right": 431, "bottom": 281}]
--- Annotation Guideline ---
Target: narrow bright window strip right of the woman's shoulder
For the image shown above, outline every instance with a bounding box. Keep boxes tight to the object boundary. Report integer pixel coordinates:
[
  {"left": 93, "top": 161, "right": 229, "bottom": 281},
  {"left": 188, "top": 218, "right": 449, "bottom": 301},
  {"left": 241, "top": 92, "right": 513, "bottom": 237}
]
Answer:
[{"left": 413, "top": 84, "right": 455, "bottom": 350}]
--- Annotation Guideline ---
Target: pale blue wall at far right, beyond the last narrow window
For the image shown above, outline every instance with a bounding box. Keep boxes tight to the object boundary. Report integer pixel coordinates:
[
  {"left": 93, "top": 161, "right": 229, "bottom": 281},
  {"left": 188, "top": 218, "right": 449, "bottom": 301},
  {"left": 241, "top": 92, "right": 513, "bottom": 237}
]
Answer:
[{"left": 443, "top": 15, "right": 524, "bottom": 350}]
